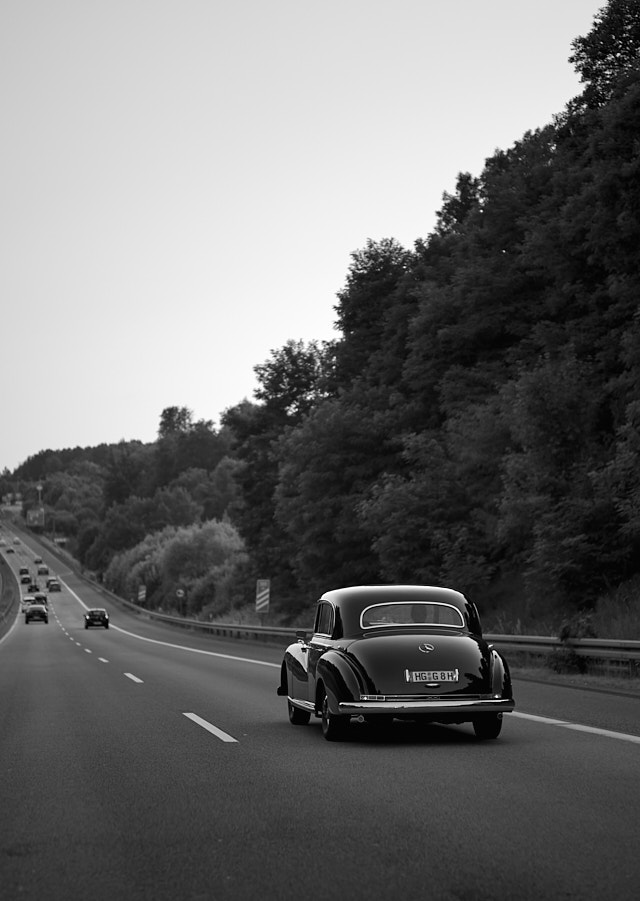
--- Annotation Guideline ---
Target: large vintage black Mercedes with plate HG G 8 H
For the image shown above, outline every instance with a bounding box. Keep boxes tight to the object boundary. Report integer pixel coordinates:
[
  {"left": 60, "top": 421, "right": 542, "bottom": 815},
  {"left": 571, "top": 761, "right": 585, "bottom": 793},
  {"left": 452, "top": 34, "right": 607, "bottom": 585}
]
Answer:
[{"left": 278, "top": 585, "right": 514, "bottom": 741}]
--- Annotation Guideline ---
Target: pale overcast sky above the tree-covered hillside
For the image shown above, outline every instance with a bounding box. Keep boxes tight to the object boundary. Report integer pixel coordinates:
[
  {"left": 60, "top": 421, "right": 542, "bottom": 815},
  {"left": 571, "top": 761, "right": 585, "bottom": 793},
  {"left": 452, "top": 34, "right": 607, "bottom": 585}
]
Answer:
[{"left": 0, "top": 0, "right": 605, "bottom": 470}]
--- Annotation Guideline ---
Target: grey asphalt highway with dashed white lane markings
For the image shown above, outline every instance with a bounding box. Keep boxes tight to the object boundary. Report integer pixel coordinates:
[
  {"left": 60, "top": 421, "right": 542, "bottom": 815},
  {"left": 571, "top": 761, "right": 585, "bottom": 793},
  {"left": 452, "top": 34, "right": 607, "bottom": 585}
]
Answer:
[{"left": 0, "top": 536, "right": 640, "bottom": 901}]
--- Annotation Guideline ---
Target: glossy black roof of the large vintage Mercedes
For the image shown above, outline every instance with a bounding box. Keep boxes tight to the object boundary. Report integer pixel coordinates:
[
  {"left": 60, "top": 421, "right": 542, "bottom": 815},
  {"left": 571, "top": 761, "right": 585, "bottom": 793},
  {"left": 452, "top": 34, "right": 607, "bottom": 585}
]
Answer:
[{"left": 318, "top": 585, "right": 479, "bottom": 637}]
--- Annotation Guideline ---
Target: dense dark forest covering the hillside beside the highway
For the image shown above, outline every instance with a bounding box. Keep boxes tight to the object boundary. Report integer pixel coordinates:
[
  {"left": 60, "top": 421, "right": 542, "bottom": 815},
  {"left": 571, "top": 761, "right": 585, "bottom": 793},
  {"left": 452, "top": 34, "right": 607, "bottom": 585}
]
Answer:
[{"left": 0, "top": 0, "right": 640, "bottom": 619}]
